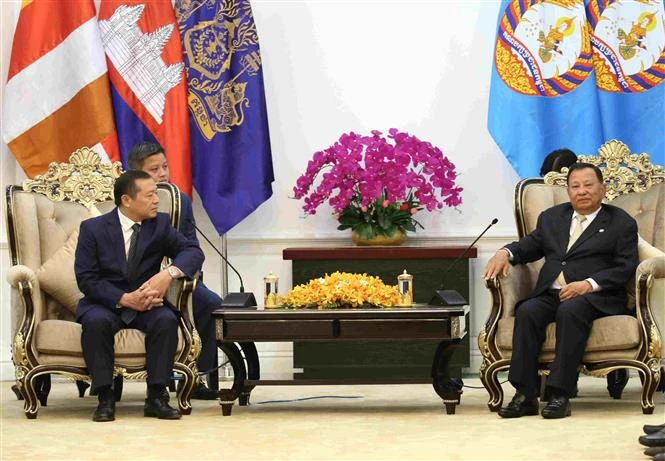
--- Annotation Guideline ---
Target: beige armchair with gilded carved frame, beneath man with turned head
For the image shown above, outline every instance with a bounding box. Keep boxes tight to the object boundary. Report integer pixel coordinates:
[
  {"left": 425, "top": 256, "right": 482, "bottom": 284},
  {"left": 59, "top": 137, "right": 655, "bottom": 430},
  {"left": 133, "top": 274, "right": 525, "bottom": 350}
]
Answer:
[{"left": 7, "top": 148, "right": 201, "bottom": 419}]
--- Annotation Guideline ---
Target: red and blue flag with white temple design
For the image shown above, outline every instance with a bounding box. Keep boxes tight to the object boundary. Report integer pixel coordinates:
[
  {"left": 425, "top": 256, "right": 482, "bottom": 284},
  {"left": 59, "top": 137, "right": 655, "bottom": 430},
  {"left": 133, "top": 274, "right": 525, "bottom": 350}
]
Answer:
[{"left": 99, "top": 0, "right": 192, "bottom": 196}]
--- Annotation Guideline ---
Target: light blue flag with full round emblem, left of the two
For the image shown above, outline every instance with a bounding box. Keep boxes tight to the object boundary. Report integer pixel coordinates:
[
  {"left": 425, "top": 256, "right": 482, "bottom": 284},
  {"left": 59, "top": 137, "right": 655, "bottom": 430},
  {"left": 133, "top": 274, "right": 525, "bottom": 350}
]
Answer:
[{"left": 488, "top": 0, "right": 603, "bottom": 178}]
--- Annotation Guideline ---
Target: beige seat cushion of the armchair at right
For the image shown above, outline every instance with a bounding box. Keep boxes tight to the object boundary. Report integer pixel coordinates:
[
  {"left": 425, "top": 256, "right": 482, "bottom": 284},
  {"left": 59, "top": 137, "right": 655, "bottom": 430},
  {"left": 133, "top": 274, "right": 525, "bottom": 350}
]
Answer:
[{"left": 496, "top": 315, "right": 640, "bottom": 353}]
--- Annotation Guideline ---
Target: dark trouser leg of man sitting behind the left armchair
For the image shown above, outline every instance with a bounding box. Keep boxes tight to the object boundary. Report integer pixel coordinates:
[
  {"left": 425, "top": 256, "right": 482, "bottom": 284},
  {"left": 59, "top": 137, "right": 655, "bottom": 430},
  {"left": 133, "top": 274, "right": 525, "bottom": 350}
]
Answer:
[{"left": 192, "top": 283, "right": 222, "bottom": 371}]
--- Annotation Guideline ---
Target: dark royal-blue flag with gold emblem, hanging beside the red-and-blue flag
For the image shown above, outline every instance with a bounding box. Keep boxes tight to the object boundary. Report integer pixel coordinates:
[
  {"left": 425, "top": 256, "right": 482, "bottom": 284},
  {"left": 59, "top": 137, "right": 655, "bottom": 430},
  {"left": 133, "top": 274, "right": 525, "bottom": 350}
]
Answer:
[{"left": 174, "top": 0, "right": 274, "bottom": 234}]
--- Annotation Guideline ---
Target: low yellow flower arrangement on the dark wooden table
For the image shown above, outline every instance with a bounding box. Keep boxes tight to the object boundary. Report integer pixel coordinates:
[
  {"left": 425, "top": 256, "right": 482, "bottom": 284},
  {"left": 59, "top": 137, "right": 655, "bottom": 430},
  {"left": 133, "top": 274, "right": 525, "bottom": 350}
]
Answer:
[{"left": 281, "top": 272, "right": 399, "bottom": 309}]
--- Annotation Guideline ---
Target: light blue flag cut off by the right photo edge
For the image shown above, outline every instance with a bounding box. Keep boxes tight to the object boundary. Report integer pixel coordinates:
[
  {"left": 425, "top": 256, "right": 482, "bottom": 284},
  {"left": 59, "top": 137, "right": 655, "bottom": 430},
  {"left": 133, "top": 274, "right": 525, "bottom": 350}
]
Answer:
[{"left": 587, "top": 0, "right": 665, "bottom": 165}]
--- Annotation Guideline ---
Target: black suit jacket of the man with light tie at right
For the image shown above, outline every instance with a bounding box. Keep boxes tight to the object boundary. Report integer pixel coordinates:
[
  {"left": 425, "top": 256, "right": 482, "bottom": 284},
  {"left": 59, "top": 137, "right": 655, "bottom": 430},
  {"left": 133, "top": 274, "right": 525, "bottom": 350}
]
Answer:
[{"left": 506, "top": 203, "right": 639, "bottom": 314}]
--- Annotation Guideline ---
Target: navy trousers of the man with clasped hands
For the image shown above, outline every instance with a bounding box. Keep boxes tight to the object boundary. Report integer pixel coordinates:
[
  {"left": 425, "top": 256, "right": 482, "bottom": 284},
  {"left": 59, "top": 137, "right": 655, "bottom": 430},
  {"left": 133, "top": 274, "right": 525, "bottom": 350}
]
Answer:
[{"left": 79, "top": 306, "right": 179, "bottom": 390}]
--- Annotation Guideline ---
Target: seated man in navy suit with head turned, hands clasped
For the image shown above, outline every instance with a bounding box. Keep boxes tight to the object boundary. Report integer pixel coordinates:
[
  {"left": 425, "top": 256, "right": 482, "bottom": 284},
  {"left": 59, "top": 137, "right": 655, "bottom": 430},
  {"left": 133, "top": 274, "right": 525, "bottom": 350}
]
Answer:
[{"left": 74, "top": 170, "right": 204, "bottom": 421}]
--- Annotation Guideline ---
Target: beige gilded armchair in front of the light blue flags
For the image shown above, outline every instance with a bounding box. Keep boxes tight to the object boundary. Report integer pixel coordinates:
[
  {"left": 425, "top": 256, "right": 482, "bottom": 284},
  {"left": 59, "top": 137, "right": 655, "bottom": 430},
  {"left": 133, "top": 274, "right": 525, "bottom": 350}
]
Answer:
[{"left": 478, "top": 140, "right": 665, "bottom": 414}]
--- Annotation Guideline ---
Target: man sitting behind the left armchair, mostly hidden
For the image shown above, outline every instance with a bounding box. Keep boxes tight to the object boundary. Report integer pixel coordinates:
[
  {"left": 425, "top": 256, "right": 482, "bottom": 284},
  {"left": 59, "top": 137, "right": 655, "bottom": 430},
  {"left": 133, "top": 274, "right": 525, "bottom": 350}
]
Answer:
[{"left": 127, "top": 142, "right": 222, "bottom": 400}]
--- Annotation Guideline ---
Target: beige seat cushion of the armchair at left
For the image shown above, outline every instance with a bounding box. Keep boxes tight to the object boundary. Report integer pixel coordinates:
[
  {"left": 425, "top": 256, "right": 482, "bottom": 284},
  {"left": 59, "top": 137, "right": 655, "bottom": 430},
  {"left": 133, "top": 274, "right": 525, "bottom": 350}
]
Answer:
[{"left": 35, "top": 320, "right": 184, "bottom": 358}]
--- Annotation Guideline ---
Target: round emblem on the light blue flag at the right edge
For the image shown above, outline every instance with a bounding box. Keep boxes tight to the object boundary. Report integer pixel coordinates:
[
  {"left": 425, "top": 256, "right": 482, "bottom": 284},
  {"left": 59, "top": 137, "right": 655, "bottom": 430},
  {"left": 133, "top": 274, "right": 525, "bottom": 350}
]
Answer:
[{"left": 588, "top": 0, "right": 665, "bottom": 93}]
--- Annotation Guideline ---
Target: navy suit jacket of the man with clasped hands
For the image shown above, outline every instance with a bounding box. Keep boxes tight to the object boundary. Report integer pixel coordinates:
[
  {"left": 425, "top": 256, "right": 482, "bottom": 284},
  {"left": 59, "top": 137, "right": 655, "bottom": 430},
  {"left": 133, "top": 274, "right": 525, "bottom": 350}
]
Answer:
[{"left": 74, "top": 208, "right": 203, "bottom": 319}]
